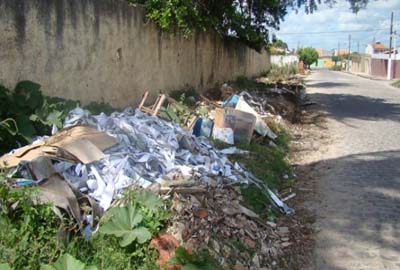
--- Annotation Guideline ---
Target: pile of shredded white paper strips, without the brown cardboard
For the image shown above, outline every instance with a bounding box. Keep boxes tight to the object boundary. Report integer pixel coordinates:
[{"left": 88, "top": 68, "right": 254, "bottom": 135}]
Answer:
[{"left": 55, "top": 108, "right": 255, "bottom": 209}]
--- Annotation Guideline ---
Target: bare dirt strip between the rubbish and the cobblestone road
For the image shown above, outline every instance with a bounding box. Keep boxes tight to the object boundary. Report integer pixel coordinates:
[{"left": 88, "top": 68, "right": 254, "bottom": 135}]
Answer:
[{"left": 279, "top": 107, "right": 331, "bottom": 270}]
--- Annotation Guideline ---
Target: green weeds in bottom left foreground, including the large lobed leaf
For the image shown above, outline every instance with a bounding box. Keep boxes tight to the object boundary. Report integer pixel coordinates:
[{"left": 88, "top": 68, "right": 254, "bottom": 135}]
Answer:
[{"left": 0, "top": 175, "right": 169, "bottom": 270}]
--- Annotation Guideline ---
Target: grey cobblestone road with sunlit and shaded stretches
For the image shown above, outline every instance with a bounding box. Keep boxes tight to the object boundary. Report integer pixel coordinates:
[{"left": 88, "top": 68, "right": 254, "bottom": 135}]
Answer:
[{"left": 307, "top": 70, "right": 400, "bottom": 270}]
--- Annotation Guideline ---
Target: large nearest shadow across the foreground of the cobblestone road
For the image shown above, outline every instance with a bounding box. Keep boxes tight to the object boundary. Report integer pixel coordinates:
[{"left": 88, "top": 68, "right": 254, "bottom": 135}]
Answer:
[{"left": 299, "top": 150, "right": 400, "bottom": 269}]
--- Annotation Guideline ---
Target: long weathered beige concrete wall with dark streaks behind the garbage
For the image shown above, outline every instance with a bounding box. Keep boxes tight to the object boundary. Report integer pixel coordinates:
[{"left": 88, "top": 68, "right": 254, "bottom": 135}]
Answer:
[{"left": 0, "top": 0, "right": 270, "bottom": 107}]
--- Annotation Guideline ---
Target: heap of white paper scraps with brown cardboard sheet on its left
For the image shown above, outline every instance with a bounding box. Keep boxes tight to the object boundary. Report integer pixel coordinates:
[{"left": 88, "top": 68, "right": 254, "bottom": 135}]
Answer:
[{"left": 0, "top": 108, "right": 292, "bottom": 215}]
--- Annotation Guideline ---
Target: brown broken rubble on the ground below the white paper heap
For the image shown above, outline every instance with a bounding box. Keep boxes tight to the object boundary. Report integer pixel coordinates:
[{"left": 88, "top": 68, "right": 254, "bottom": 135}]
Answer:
[{"left": 167, "top": 185, "right": 291, "bottom": 269}]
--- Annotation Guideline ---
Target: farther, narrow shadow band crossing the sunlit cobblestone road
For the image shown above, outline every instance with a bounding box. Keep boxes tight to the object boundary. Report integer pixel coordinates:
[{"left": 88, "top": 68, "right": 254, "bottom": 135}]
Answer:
[{"left": 308, "top": 93, "right": 400, "bottom": 122}]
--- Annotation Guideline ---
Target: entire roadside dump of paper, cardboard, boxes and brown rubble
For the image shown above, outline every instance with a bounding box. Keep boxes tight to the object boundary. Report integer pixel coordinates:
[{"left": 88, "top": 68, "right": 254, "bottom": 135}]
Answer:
[{"left": 0, "top": 77, "right": 306, "bottom": 269}]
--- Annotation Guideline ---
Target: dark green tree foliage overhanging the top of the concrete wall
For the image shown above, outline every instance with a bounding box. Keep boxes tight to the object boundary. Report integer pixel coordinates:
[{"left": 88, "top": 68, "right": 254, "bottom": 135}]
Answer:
[{"left": 127, "top": 0, "right": 368, "bottom": 50}]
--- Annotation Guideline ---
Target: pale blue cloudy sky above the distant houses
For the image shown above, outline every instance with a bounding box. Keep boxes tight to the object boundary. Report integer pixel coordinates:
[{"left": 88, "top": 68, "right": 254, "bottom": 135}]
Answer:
[{"left": 273, "top": 0, "right": 400, "bottom": 53}]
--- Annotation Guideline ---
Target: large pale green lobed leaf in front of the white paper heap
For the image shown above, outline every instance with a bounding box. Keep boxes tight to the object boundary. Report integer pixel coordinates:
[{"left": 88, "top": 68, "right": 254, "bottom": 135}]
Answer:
[{"left": 100, "top": 204, "right": 151, "bottom": 247}]
